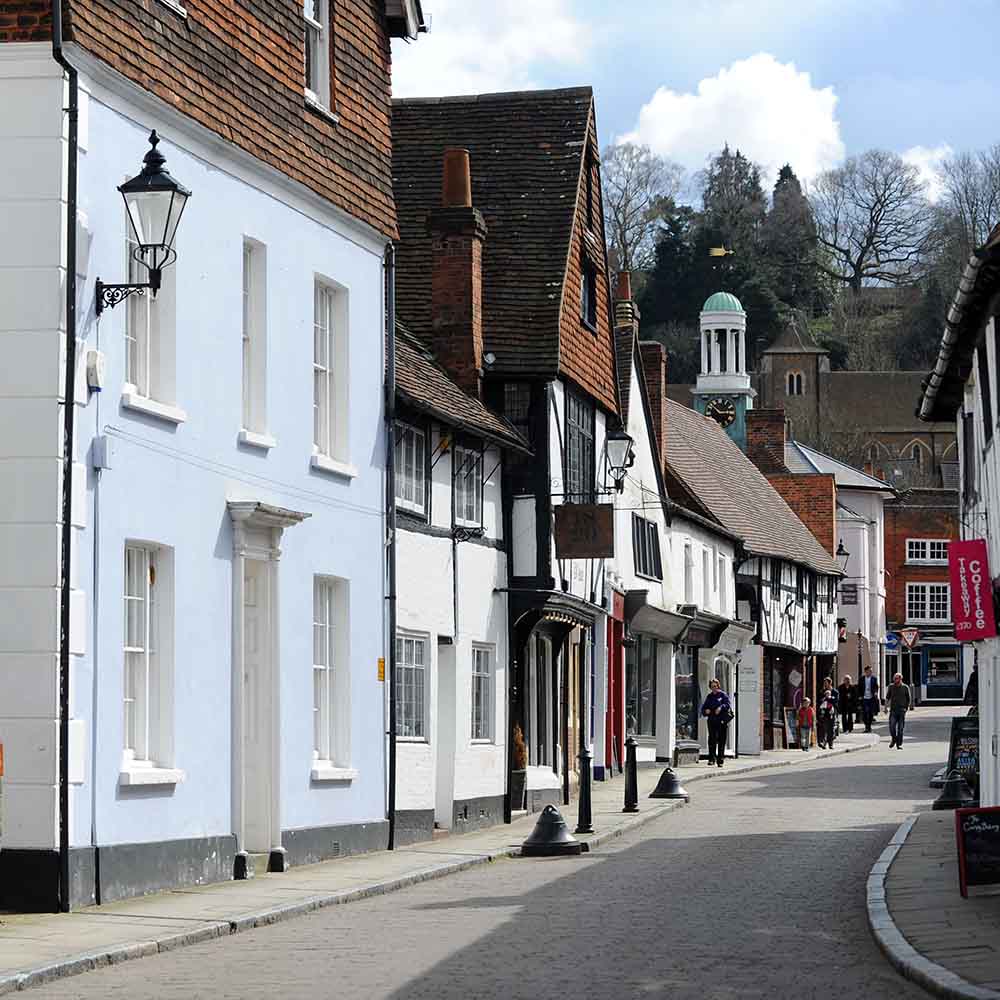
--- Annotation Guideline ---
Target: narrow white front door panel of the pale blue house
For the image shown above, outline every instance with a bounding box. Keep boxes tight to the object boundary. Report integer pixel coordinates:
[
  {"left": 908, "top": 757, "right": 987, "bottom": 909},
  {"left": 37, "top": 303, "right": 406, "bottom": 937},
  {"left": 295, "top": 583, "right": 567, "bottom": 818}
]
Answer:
[{"left": 241, "top": 559, "right": 274, "bottom": 854}]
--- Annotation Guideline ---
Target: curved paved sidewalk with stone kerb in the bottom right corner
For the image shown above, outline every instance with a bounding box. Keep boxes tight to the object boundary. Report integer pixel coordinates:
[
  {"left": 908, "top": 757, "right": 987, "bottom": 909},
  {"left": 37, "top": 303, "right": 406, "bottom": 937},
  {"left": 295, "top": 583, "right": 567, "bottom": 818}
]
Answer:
[{"left": 868, "top": 811, "right": 1000, "bottom": 1000}]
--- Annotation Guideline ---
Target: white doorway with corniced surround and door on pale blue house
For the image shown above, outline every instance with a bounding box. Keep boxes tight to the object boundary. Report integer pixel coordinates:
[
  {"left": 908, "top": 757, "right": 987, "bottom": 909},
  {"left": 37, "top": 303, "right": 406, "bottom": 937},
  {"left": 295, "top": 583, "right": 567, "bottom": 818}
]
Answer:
[{"left": 228, "top": 500, "right": 310, "bottom": 878}]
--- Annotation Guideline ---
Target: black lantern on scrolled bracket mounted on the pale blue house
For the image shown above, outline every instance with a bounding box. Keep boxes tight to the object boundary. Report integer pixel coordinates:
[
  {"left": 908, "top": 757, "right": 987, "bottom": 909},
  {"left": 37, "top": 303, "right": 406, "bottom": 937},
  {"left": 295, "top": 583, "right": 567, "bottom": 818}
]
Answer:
[{"left": 96, "top": 129, "right": 191, "bottom": 316}]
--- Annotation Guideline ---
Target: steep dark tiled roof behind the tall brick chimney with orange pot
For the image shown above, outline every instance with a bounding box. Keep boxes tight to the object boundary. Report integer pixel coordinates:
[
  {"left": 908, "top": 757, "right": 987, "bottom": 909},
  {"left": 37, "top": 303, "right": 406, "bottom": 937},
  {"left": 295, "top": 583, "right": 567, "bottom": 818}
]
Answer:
[{"left": 392, "top": 87, "right": 593, "bottom": 376}]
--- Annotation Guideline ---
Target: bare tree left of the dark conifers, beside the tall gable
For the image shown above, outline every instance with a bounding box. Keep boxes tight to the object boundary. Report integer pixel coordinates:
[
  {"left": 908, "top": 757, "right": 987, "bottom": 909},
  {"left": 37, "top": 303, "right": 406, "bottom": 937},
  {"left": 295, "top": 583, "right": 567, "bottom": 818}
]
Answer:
[{"left": 601, "top": 142, "right": 684, "bottom": 271}]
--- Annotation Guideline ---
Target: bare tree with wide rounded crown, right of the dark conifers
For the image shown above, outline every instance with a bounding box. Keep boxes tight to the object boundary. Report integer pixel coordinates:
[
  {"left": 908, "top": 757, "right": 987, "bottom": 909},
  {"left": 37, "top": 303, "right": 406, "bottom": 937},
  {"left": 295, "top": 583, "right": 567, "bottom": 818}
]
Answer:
[{"left": 810, "top": 149, "right": 934, "bottom": 293}]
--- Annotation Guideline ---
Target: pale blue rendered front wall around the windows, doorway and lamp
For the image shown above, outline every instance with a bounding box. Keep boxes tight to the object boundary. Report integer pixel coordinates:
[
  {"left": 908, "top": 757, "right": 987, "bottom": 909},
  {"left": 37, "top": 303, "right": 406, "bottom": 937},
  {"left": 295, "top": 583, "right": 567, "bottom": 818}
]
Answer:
[{"left": 58, "top": 80, "right": 385, "bottom": 844}]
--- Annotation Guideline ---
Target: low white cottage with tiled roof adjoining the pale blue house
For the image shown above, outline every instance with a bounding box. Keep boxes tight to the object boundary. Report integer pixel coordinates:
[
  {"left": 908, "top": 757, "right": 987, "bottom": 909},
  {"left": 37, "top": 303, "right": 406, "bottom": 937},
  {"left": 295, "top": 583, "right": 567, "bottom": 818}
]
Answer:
[{"left": 395, "top": 330, "right": 528, "bottom": 844}]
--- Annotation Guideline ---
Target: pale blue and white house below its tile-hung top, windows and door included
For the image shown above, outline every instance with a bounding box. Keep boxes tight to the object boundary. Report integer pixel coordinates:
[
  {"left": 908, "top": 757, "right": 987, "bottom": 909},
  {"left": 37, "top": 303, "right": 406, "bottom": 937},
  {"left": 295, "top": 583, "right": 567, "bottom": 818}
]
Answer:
[{"left": 0, "top": 5, "right": 420, "bottom": 908}]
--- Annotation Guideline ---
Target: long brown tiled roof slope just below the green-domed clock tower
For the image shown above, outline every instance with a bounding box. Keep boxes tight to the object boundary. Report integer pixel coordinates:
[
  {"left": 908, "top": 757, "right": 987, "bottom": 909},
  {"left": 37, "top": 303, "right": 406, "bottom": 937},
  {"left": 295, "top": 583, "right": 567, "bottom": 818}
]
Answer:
[{"left": 667, "top": 400, "right": 840, "bottom": 575}]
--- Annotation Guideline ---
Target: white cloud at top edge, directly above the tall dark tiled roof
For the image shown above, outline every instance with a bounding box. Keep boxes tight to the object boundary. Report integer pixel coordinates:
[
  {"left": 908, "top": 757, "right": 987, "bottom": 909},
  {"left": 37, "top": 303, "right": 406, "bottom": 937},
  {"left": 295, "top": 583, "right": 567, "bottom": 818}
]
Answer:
[{"left": 392, "top": 0, "right": 590, "bottom": 97}]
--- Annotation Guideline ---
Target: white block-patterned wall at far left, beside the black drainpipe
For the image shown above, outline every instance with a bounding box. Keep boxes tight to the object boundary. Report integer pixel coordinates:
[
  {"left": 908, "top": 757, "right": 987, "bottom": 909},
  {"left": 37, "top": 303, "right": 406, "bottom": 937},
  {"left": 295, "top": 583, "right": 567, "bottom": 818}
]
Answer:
[{"left": 0, "top": 43, "right": 89, "bottom": 849}]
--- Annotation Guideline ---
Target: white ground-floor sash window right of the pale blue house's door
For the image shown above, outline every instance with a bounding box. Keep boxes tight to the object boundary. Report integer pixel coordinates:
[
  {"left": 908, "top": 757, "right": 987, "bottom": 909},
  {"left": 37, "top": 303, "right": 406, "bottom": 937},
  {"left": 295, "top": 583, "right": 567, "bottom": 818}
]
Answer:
[{"left": 312, "top": 576, "right": 357, "bottom": 781}]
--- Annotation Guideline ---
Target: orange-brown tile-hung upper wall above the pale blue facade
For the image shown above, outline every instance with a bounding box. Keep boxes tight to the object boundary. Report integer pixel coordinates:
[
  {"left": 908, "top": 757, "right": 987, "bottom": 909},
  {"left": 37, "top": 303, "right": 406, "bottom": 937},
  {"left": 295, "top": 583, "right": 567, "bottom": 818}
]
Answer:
[{"left": 0, "top": 0, "right": 396, "bottom": 236}]
